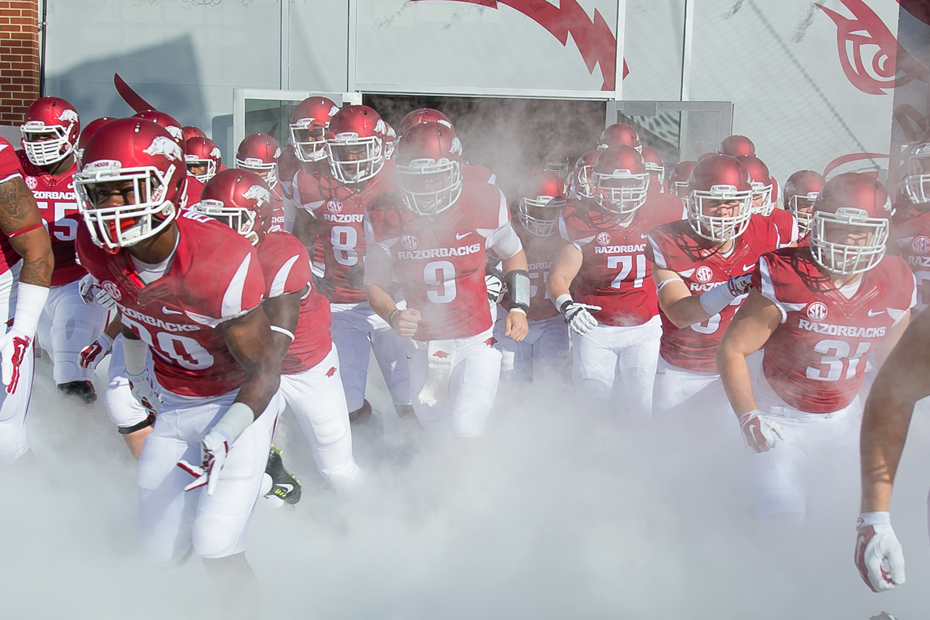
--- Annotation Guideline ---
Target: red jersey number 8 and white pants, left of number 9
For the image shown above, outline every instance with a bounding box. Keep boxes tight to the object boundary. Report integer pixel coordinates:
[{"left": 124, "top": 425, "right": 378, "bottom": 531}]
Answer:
[{"left": 294, "top": 161, "right": 410, "bottom": 411}]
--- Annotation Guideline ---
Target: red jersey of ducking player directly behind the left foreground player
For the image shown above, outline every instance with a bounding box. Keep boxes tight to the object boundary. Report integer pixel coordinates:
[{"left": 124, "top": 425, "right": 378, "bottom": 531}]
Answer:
[{"left": 256, "top": 231, "right": 333, "bottom": 375}]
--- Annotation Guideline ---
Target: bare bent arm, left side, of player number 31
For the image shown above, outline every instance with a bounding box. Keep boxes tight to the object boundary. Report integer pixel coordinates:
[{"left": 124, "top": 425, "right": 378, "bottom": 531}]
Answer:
[{"left": 717, "top": 290, "right": 781, "bottom": 417}]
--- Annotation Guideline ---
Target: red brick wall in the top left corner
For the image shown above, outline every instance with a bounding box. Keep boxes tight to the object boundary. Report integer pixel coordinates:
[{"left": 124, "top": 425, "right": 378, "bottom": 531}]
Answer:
[{"left": 0, "top": 0, "right": 39, "bottom": 125}]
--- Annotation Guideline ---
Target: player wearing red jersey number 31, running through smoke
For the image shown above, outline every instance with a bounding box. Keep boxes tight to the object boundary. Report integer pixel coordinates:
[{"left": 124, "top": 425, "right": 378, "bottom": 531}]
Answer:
[{"left": 717, "top": 173, "right": 915, "bottom": 527}]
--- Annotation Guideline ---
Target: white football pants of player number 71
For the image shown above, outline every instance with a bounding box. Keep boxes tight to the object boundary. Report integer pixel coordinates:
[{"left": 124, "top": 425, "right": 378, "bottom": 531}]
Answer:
[{"left": 571, "top": 316, "right": 662, "bottom": 418}]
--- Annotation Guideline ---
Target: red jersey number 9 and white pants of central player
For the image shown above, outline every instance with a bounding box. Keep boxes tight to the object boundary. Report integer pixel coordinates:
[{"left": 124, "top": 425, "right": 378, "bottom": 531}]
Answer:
[{"left": 365, "top": 182, "right": 522, "bottom": 437}]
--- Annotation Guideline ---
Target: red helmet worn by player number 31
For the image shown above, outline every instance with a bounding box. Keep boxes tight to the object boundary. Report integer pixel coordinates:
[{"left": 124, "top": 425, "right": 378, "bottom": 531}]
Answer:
[{"left": 810, "top": 172, "right": 892, "bottom": 275}]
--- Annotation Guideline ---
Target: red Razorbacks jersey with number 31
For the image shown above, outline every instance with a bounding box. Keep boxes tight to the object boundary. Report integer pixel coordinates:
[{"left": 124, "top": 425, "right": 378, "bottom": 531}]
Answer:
[{"left": 752, "top": 248, "right": 915, "bottom": 413}]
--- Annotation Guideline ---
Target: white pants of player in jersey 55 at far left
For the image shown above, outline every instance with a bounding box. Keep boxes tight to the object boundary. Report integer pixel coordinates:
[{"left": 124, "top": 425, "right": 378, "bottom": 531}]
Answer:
[{"left": 36, "top": 281, "right": 107, "bottom": 385}]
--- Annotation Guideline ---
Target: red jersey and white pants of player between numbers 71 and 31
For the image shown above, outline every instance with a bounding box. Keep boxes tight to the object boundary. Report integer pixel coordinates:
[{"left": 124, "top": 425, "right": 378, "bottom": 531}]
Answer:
[{"left": 647, "top": 215, "right": 779, "bottom": 422}]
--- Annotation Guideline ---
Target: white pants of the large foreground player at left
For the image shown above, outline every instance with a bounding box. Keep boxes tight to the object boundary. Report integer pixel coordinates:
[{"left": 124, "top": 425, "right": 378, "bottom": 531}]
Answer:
[{"left": 136, "top": 389, "right": 281, "bottom": 565}]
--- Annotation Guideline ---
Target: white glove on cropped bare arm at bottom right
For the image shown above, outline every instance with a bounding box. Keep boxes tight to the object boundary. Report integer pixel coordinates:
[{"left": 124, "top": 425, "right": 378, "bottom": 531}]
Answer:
[{"left": 856, "top": 512, "right": 904, "bottom": 592}]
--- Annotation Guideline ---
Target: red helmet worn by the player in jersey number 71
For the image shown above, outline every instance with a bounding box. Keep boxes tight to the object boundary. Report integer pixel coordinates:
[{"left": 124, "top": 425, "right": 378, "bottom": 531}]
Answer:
[{"left": 591, "top": 145, "right": 649, "bottom": 215}]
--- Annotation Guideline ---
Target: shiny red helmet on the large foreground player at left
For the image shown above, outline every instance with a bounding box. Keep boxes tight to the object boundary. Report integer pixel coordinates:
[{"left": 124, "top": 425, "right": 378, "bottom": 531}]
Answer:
[{"left": 74, "top": 118, "right": 187, "bottom": 252}]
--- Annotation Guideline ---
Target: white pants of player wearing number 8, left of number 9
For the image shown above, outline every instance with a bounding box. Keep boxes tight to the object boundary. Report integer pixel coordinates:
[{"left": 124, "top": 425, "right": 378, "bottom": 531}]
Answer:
[{"left": 330, "top": 302, "right": 410, "bottom": 411}]
